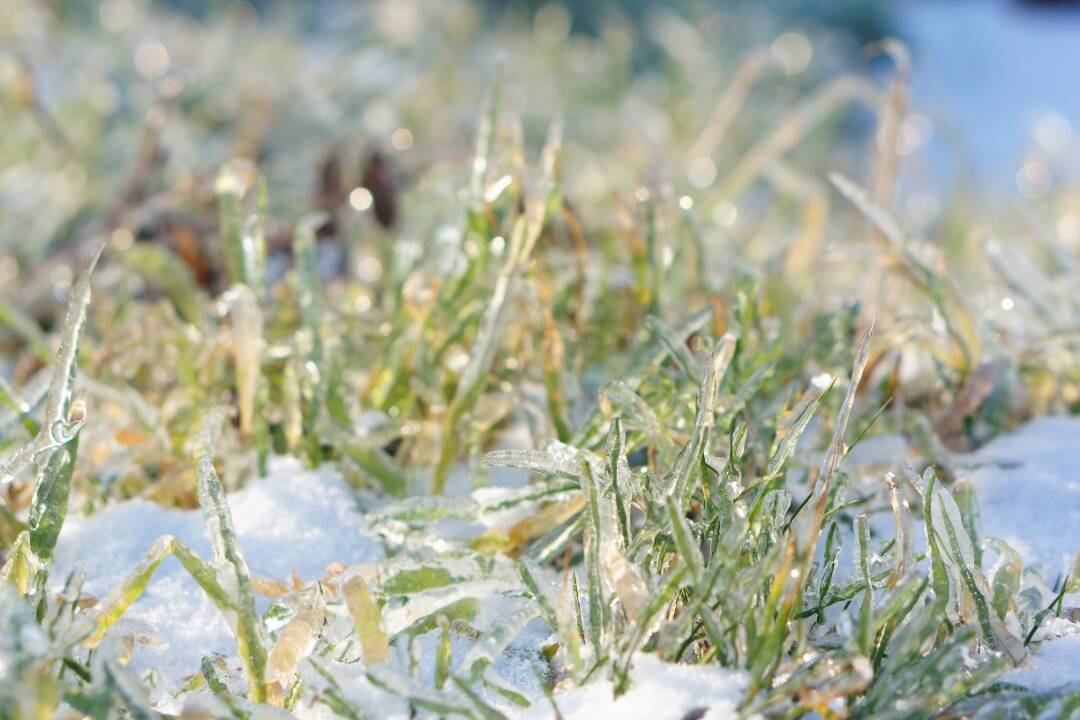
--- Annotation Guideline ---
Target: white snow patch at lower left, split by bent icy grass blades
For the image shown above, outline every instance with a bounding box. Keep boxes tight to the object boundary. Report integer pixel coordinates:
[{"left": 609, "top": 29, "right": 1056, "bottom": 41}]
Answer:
[{"left": 52, "top": 458, "right": 382, "bottom": 692}]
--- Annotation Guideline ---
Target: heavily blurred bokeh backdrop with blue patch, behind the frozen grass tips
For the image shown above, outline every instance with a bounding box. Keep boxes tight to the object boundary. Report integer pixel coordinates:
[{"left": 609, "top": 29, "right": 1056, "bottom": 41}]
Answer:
[{"left": 0, "top": 0, "right": 1080, "bottom": 297}]
